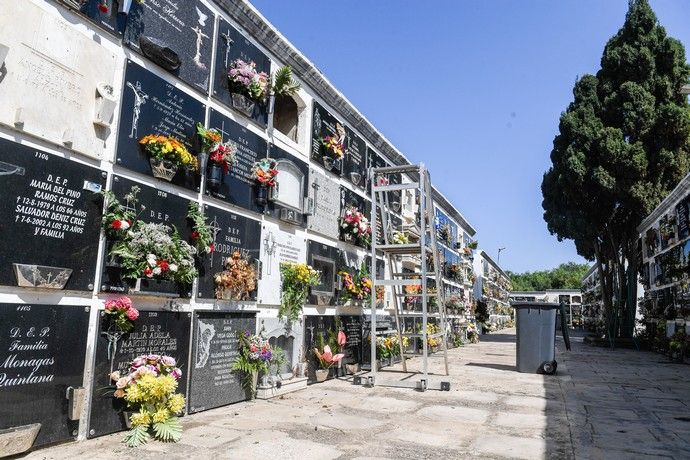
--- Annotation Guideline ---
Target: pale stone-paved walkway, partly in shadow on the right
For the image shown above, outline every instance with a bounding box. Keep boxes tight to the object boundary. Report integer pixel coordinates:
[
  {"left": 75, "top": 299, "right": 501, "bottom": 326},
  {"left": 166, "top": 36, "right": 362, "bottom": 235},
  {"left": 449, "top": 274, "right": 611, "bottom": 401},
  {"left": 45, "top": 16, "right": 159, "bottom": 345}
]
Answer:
[{"left": 18, "top": 330, "right": 690, "bottom": 460}]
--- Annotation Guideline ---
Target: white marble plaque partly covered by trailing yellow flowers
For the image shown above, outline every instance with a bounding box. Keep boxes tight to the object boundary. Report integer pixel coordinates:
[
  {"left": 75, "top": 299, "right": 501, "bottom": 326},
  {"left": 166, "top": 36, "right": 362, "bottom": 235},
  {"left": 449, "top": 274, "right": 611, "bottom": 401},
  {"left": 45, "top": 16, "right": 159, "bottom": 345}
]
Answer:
[{"left": 258, "top": 222, "right": 307, "bottom": 305}]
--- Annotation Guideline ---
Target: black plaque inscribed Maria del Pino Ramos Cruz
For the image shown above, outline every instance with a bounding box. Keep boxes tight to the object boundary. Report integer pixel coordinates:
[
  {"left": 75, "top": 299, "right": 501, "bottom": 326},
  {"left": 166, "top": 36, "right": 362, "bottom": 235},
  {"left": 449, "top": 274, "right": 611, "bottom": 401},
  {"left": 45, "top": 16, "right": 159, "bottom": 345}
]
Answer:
[{"left": 0, "top": 139, "right": 105, "bottom": 291}]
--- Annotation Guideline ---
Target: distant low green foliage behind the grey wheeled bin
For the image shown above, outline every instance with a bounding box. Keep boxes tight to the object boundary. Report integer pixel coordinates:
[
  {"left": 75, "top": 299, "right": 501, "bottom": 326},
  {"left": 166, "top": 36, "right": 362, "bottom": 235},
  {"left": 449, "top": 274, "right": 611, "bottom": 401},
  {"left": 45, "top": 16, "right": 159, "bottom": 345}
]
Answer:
[{"left": 506, "top": 262, "right": 589, "bottom": 291}]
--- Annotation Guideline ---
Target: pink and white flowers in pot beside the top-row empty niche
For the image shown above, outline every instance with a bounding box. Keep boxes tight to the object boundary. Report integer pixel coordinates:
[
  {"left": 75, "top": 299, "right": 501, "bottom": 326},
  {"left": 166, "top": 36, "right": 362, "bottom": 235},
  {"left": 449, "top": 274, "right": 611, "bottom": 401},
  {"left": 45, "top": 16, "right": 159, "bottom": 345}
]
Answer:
[{"left": 228, "top": 59, "right": 270, "bottom": 117}]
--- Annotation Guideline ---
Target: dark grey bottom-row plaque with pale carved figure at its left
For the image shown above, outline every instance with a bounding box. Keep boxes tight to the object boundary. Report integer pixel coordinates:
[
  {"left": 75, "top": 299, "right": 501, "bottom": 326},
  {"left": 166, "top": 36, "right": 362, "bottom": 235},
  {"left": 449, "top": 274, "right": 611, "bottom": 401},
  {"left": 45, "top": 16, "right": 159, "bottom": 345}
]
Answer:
[{"left": 187, "top": 311, "right": 256, "bottom": 414}]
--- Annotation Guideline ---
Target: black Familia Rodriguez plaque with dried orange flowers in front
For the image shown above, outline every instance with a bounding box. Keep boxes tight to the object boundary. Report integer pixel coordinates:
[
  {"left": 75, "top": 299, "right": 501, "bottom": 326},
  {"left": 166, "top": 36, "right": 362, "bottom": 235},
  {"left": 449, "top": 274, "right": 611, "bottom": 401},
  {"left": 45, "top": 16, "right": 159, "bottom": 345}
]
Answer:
[{"left": 197, "top": 205, "right": 261, "bottom": 301}]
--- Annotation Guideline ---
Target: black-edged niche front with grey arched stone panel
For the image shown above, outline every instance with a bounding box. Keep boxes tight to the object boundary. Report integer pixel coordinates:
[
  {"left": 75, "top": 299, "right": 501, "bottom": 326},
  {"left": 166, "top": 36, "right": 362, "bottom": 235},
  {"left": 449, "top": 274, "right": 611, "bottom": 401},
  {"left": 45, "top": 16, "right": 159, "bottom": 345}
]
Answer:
[{"left": 266, "top": 145, "right": 309, "bottom": 227}]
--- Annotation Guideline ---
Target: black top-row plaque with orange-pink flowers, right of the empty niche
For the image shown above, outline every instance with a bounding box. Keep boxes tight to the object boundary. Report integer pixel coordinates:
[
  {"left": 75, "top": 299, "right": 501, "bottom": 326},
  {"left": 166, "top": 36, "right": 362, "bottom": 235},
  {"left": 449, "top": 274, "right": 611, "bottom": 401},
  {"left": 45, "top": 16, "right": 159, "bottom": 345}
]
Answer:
[{"left": 309, "top": 101, "right": 348, "bottom": 176}]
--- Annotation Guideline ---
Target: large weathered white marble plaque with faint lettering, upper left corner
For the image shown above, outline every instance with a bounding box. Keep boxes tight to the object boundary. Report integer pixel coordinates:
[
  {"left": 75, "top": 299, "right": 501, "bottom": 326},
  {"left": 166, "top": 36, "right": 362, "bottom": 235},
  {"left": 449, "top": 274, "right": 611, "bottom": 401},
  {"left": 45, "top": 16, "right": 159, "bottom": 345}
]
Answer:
[{"left": 0, "top": 0, "right": 119, "bottom": 158}]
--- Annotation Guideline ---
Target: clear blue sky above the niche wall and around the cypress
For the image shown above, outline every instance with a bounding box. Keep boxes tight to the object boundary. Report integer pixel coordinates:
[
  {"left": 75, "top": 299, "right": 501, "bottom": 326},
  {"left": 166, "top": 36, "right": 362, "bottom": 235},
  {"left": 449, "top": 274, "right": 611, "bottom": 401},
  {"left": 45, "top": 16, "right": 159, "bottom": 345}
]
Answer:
[{"left": 251, "top": 0, "right": 690, "bottom": 271}]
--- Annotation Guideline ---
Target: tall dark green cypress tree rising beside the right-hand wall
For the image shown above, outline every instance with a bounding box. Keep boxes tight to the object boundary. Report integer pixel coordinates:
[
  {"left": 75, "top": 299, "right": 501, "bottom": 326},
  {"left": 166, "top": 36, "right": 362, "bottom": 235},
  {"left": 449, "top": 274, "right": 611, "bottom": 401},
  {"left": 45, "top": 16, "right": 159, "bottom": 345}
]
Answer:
[{"left": 542, "top": 0, "right": 690, "bottom": 336}]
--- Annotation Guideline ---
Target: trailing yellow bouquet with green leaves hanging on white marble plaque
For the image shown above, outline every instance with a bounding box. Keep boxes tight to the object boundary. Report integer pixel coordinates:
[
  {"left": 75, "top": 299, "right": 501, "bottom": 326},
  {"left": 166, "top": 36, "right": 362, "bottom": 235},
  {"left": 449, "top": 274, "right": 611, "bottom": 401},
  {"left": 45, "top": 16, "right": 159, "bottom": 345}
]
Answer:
[{"left": 278, "top": 262, "right": 321, "bottom": 322}]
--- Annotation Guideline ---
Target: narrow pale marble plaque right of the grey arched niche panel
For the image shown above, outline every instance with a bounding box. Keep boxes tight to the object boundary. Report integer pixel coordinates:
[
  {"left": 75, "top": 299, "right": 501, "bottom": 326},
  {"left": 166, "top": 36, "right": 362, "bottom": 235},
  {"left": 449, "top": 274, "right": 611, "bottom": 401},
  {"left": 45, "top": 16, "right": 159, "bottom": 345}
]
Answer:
[{"left": 307, "top": 169, "right": 340, "bottom": 240}]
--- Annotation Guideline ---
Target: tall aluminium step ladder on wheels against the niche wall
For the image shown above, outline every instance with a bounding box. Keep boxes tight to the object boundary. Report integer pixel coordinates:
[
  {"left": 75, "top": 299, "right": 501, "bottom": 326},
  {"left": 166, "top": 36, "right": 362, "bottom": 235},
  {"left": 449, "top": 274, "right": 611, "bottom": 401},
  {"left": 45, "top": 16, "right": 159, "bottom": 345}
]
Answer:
[{"left": 356, "top": 164, "right": 450, "bottom": 391}]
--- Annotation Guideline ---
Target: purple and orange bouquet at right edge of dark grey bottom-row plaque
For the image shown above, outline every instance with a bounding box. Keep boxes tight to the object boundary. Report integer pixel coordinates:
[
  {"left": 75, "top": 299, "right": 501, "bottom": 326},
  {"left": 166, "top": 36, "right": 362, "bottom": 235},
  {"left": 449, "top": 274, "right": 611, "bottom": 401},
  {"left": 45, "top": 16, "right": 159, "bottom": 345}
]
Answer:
[{"left": 232, "top": 331, "right": 273, "bottom": 399}]
